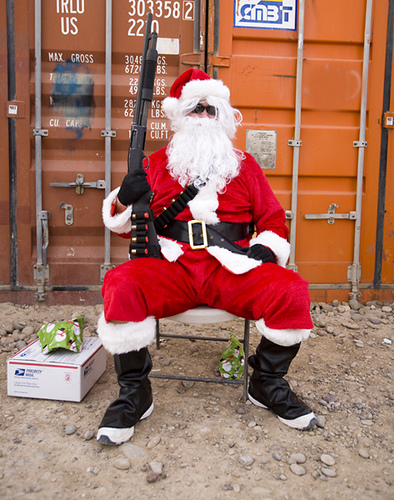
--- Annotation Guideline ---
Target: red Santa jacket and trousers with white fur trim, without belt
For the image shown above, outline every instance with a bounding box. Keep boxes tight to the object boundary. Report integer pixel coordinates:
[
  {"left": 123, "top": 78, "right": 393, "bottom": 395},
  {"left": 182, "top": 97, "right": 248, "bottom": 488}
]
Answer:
[{"left": 98, "top": 148, "right": 313, "bottom": 354}]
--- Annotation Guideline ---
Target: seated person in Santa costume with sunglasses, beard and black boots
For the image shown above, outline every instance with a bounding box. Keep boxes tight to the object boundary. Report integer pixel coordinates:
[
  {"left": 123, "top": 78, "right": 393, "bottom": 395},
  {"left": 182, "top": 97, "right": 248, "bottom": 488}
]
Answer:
[{"left": 97, "top": 69, "right": 316, "bottom": 444}]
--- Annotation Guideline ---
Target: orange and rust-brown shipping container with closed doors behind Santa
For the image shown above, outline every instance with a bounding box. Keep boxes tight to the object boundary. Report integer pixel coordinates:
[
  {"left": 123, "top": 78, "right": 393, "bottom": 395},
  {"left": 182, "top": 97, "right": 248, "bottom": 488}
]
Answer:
[{"left": 0, "top": 0, "right": 394, "bottom": 303}]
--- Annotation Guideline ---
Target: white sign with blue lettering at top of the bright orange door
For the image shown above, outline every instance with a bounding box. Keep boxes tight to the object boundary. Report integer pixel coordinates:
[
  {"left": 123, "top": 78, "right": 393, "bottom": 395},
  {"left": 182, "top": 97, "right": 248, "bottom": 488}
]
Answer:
[{"left": 234, "top": 0, "right": 297, "bottom": 31}]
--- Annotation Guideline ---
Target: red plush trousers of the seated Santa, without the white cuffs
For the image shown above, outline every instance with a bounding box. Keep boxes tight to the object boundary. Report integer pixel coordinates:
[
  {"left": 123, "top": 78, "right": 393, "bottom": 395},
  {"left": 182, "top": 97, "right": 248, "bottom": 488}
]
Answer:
[{"left": 102, "top": 250, "right": 313, "bottom": 330}]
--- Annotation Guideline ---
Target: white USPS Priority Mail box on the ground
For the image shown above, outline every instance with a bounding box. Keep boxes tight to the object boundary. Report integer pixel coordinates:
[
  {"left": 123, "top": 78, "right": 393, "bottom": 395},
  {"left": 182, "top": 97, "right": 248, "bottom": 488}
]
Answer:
[{"left": 7, "top": 337, "right": 107, "bottom": 402}]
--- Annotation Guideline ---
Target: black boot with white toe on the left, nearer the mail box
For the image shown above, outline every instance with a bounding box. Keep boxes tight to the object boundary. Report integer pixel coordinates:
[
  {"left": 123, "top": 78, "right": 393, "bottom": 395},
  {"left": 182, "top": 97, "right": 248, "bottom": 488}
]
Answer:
[{"left": 97, "top": 347, "right": 153, "bottom": 444}]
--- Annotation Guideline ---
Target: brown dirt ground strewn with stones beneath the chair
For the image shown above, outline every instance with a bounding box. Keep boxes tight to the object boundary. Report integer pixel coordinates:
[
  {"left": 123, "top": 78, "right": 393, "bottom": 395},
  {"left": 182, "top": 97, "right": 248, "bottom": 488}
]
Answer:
[{"left": 0, "top": 303, "right": 394, "bottom": 500}]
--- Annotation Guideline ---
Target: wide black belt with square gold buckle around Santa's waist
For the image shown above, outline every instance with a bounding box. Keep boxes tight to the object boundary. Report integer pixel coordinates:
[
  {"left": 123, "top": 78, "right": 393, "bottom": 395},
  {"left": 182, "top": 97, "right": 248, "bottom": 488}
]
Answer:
[{"left": 159, "top": 220, "right": 249, "bottom": 255}]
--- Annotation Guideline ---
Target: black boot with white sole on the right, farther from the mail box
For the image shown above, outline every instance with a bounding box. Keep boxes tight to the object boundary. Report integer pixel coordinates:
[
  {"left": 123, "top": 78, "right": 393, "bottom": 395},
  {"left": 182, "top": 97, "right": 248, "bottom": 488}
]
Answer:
[{"left": 248, "top": 337, "right": 316, "bottom": 430}]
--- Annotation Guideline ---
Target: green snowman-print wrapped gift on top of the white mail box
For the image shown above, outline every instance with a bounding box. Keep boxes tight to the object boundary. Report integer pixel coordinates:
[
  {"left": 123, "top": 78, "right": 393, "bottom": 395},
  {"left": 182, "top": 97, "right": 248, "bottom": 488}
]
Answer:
[{"left": 37, "top": 316, "right": 85, "bottom": 354}]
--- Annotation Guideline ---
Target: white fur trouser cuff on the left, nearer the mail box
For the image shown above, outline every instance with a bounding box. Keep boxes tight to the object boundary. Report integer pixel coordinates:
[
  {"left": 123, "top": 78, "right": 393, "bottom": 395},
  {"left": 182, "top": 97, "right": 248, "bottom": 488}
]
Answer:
[{"left": 97, "top": 313, "right": 156, "bottom": 354}]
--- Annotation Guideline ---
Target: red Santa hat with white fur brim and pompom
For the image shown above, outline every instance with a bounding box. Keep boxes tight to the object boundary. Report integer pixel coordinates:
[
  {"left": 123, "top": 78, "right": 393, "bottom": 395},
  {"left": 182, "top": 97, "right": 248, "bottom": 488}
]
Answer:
[{"left": 162, "top": 68, "right": 230, "bottom": 115}]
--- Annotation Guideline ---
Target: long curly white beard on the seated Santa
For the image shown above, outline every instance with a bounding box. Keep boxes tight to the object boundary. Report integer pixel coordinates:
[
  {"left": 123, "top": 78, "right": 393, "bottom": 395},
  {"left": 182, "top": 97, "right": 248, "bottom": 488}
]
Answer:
[{"left": 167, "top": 116, "right": 242, "bottom": 193}]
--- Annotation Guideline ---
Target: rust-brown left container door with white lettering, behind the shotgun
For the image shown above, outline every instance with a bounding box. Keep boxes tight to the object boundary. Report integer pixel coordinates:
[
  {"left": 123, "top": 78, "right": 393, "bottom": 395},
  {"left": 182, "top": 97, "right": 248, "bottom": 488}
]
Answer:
[{"left": 31, "top": 0, "right": 202, "bottom": 296}]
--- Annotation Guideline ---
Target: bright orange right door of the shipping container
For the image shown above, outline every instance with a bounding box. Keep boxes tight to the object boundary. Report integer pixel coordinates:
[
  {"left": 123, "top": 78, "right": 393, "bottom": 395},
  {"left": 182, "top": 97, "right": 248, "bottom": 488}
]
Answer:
[{"left": 210, "top": 0, "right": 392, "bottom": 300}]
